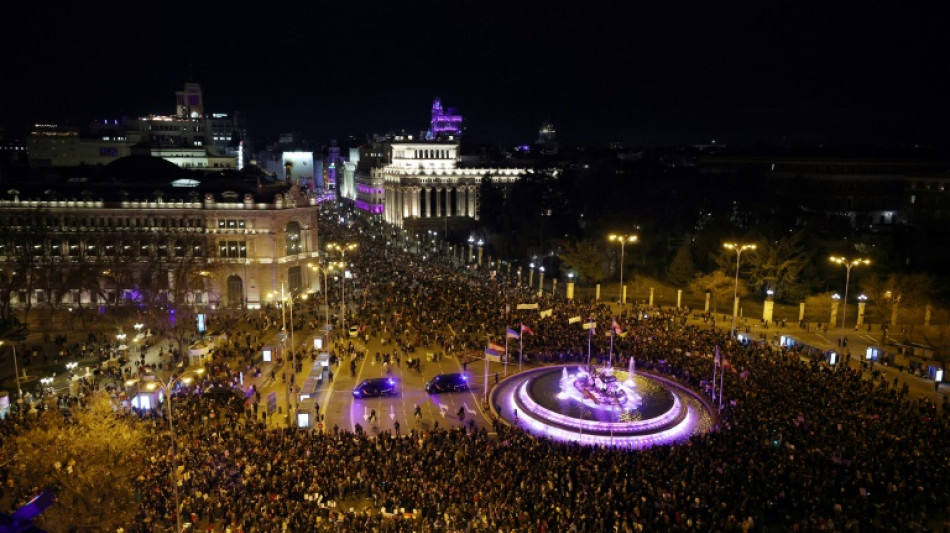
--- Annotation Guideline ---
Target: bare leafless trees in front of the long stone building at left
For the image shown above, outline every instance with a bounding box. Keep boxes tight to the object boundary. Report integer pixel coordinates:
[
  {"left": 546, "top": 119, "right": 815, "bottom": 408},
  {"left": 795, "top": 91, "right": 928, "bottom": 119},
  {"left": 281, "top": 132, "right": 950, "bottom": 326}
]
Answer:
[{"left": 0, "top": 209, "right": 215, "bottom": 354}]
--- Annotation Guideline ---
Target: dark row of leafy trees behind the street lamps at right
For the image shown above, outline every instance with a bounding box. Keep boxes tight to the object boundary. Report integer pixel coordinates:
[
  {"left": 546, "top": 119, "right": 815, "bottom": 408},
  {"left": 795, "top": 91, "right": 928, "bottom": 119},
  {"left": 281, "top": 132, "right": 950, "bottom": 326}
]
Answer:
[{"left": 479, "top": 161, "right": 948, "bottom": 322}]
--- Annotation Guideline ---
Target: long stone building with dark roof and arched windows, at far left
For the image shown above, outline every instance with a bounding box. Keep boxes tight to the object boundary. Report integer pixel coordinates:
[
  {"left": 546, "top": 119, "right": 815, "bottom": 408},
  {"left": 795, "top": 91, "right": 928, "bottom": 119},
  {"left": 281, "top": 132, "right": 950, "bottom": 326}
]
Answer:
[{"left": 0, "top": 156, "right": 319, "bottom": 309}]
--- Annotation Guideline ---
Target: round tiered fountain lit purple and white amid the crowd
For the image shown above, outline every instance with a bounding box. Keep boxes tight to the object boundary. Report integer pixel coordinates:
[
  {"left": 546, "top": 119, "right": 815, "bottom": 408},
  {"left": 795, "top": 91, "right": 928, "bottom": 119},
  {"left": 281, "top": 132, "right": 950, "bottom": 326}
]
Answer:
[{"left": 492, "top": 363, "right": 713, "bottom": 448}]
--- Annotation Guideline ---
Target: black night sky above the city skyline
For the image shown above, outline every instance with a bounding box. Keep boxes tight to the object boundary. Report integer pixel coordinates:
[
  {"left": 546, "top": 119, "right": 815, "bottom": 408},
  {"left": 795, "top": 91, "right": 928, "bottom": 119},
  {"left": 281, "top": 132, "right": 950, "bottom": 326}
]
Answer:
[{"left": 0, "top": 0, "right": 950, "bottom": 144}]
